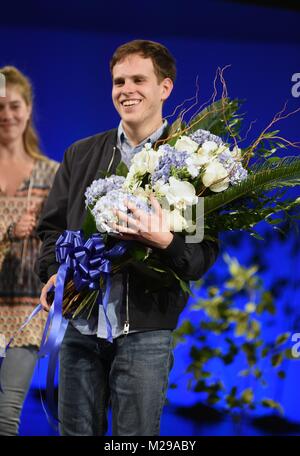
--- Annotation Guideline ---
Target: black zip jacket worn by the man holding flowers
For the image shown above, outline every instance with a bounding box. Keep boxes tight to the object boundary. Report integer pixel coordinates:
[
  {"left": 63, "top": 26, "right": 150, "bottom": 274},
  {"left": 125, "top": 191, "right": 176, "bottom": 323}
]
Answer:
[{"left": 36, "top": 129, "right": 218, "bottom": 330}]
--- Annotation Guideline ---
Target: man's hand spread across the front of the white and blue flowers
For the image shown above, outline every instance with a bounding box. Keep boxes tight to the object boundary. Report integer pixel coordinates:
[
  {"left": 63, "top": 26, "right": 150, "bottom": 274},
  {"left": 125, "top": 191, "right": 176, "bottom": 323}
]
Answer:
[{"left": 113, "top": 196, "right": 173, "bottom": 249}]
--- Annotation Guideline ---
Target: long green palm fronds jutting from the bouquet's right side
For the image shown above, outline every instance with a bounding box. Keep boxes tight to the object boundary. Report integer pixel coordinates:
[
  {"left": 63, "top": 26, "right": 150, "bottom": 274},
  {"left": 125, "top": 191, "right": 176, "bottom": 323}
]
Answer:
[{"left": 200, "top": 157, "right": 300, "bottom": 240}]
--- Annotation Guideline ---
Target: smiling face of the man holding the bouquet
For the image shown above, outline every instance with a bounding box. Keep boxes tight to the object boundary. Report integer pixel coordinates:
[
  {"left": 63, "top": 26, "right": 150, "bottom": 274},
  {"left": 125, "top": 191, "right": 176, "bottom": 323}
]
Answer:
[{"left": 112, "top": 54, "right": 173, "bottom": 132}]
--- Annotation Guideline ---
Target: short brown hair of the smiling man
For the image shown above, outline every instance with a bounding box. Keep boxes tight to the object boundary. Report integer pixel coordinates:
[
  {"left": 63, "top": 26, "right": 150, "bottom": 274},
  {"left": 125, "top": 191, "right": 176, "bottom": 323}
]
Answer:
[{"left": 110, "top": 40, "right": 176, "bottom": 82}]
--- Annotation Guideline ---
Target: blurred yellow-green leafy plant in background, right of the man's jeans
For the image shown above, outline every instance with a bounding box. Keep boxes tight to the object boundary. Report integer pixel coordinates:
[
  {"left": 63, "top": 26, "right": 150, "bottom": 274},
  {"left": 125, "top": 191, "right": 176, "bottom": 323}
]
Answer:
[{"left": 175, "top": 255, "right": 290, "bottom": 413}]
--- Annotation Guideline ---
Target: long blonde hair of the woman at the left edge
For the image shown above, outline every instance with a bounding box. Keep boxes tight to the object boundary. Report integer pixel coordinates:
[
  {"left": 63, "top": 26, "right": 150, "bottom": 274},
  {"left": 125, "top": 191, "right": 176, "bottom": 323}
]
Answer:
[{"left": 0, "top": 65, "right": 46, "bottom": 160}]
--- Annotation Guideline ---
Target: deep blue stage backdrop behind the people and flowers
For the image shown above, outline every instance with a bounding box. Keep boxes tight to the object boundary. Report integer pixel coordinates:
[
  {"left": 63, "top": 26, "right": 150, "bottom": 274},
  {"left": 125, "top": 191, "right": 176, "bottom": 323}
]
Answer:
[{"left": 0, "top": 2, "right": 300, "bottom": 432}]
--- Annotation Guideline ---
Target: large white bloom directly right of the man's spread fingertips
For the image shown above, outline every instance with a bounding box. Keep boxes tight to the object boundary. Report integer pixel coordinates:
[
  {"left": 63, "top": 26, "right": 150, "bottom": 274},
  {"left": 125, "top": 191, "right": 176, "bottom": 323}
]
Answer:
[{"left": 165, "top": 177, "right": 198, "bottom": 209}]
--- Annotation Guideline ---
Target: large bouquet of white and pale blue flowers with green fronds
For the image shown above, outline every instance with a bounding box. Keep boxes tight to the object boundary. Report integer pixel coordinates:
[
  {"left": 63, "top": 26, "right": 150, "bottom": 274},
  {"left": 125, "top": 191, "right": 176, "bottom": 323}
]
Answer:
[{"left": 58, "top": 96, "right": 300, "bottom": 317}]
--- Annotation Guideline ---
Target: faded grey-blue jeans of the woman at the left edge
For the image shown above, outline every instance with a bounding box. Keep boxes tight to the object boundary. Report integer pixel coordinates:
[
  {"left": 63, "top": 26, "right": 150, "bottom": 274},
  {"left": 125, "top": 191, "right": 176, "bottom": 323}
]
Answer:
[{"left": 0, "top": 347, "right": 38, "bottom": 436}]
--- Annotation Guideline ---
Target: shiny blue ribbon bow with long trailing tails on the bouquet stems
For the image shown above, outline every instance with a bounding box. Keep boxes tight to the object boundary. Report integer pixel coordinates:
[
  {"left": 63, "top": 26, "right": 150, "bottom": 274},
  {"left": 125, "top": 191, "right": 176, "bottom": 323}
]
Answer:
[{"left": 0, "top": 230, "right": 130, "bottom": 424}]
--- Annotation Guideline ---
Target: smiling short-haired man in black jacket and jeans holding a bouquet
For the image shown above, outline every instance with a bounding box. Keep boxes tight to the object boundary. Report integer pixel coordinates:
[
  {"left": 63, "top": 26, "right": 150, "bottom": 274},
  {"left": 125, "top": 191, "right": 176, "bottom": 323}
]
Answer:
[{"left": 38, "top": 40, "right": 218, "bottom": 436}]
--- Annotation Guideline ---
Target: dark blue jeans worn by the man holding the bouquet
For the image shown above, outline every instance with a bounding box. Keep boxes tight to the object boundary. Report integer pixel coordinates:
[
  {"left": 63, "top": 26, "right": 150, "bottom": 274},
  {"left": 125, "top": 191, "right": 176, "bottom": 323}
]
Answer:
[{"left": 59, "top": 325, "right": 173, "bottom": 436}]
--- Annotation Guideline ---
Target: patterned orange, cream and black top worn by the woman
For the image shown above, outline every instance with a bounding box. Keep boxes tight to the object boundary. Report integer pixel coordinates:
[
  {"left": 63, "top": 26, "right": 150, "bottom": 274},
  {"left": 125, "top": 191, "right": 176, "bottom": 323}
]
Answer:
[{"left": 0, "top": 159, "right": 59, "bottom": 347}]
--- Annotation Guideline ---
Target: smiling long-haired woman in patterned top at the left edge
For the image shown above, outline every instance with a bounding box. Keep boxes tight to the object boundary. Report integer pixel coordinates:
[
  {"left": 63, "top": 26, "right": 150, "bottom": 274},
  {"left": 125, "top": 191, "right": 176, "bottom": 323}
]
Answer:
[{"left": 0, "top": 66, "right": 58, "bottom": 435}]
